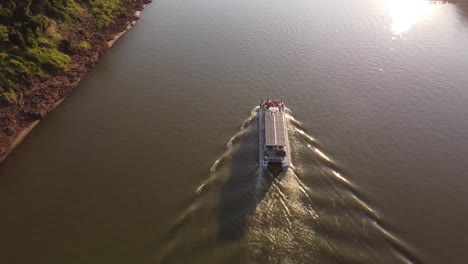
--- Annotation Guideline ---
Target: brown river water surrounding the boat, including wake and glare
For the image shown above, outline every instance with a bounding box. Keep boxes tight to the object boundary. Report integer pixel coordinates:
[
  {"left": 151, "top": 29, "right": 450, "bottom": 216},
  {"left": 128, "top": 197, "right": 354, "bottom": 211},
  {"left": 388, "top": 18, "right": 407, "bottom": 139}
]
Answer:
[{"left": 0, "top": 0, "right": 468, "bottom": 264}]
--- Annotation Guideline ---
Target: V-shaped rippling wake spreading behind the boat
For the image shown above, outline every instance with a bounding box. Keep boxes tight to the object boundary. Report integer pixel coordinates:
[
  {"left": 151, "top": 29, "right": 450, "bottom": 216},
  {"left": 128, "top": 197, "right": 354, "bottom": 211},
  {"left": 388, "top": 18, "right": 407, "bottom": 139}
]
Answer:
[{"left": 150, "top": 107, "right": 417, "bottom": 263}]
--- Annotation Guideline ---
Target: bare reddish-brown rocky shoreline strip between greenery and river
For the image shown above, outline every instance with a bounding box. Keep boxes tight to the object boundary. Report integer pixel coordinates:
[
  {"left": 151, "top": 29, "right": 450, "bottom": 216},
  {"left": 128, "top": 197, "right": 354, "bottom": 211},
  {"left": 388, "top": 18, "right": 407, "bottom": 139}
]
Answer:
[{"left": 0, "top": 0, "right": 151, "bottom": 163}]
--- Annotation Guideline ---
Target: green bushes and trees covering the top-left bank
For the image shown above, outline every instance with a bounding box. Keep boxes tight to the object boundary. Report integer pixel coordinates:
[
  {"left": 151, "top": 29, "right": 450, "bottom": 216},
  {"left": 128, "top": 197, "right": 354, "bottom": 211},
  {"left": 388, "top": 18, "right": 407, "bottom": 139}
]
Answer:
[{"left": 0, "top": 0, "right": 134, "bottom": 103}]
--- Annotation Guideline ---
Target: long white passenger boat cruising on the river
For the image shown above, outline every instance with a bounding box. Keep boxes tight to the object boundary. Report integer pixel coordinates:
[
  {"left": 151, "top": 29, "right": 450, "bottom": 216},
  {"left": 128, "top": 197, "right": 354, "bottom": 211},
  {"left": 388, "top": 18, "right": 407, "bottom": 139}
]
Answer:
[{"left": 258, "top": 99, "right": 291, "bottom": 170}]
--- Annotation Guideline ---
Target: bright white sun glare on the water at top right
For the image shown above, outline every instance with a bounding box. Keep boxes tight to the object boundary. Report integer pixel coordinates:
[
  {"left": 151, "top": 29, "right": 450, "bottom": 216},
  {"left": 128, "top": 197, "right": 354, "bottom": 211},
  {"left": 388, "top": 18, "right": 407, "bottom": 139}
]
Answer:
[{"left": 385, "top": 0, "right": 439, "bottom": 35}]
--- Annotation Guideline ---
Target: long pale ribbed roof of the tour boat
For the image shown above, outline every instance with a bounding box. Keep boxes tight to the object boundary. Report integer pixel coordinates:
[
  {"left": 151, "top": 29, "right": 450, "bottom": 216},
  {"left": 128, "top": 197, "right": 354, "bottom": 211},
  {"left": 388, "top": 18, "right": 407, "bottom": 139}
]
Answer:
[{"left": 265, "top": 107, "right": 286, "bottom": 146}]
